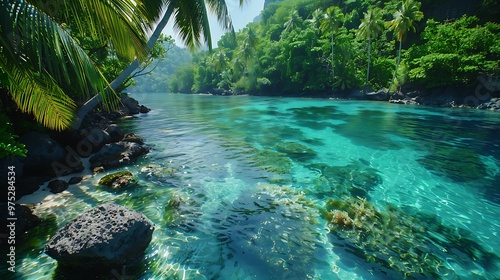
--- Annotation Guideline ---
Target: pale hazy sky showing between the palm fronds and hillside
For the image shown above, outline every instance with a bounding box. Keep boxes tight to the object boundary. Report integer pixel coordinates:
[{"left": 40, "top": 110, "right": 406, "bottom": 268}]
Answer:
[{"left": 163, "top": 0, "right": 264, "bottom": 48}]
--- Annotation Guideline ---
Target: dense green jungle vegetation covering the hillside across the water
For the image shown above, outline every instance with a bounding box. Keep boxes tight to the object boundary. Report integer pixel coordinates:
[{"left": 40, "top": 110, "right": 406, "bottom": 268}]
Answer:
[{"left": 134, "top": 0, "right": 500, "bottom": 95}]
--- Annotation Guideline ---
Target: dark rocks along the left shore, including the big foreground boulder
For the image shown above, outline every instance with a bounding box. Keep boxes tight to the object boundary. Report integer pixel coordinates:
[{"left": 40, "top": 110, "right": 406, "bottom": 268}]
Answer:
[{"left": 0, "top": 95, "right": 154, "bottom": 269}]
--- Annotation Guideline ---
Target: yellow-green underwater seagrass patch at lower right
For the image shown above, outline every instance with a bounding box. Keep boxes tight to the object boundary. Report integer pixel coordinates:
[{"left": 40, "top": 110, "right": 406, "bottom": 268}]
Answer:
[{"left": 321, "top": 197, "right": 499, "bottom": 279}]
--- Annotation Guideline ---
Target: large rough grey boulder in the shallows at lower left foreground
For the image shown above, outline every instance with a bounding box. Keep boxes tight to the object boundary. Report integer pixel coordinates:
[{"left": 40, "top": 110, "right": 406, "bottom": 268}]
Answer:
[{"left": 45, "top": 202, "right": 154, "bottom": 269}]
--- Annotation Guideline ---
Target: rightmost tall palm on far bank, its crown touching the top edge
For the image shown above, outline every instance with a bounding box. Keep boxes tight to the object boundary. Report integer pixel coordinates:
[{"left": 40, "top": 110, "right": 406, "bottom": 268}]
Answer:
[{"left": 387, "top": 0, "right": 424, "bottom": 90}]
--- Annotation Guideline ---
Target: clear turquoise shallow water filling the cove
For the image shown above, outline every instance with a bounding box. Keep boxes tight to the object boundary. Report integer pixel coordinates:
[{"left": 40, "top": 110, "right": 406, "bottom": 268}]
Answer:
[{"left": 3, "top": 94, "right": 500, "bottom": 279}]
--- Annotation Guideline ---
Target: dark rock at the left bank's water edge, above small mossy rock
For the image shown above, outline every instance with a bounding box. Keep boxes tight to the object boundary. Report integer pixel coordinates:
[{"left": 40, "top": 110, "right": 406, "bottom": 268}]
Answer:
[{"left": 89, "top": 141, "right": 149, "bottom": 169}]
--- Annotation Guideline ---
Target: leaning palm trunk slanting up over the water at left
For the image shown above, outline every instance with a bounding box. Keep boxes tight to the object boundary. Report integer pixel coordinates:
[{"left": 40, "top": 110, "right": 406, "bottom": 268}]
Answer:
[{"left": 71, "top": 0, "right": 177, "bottom": 130}]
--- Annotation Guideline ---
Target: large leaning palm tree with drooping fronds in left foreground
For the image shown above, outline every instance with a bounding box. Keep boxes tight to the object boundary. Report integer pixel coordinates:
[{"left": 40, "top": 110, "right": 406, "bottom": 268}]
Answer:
[{"left": 0, "top": 0, "right": 239, "bottom": 130}]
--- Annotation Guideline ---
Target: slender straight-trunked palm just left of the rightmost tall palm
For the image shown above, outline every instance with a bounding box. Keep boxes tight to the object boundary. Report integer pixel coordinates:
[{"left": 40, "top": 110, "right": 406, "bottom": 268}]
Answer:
[{"left": 357, "top": 8, "right": 384, "bottom": 84}]
